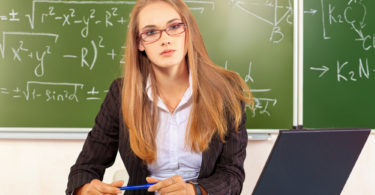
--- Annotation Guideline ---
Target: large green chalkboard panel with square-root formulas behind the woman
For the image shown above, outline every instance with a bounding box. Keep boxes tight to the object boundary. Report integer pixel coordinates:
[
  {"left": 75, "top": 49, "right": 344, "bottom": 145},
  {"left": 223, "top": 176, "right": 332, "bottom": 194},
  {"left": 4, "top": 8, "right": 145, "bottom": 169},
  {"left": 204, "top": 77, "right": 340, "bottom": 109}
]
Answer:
[{"left": 0, "top": 0, "right": 293, "bottom": 129}]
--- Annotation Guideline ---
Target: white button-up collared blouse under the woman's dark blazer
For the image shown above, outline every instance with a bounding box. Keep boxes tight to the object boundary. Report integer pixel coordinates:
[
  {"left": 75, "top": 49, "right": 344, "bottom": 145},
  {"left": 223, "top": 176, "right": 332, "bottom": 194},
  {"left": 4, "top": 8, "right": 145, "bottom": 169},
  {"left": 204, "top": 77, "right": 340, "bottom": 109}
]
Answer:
[{"left": 146, "top": 75, "right": 202, "bottom": 181}]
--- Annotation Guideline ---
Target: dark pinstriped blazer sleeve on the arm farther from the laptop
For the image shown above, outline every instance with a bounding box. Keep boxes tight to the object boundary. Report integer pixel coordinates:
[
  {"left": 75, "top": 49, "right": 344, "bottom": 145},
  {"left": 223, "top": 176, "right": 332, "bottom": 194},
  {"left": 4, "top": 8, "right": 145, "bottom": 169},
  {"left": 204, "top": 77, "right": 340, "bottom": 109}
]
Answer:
[{"left": 66, "top": 79, "right": 121, "bottom": 194}]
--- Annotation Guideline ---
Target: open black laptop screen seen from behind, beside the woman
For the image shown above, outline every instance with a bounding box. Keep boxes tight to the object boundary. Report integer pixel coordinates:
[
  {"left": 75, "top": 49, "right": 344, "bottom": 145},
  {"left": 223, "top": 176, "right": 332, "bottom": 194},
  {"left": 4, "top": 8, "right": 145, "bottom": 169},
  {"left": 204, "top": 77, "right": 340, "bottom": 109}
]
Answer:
[{"left": 253, "top": 129, "right": 370, "bottom": 195}]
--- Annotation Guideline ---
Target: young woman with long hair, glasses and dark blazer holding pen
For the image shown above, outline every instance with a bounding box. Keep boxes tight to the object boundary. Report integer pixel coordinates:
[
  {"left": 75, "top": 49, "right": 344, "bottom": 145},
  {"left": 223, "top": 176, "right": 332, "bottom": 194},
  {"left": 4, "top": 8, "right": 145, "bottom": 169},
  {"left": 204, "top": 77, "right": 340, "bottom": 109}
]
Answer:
[{"left": 66, "top": 0, "right": 252, "bottom": 195}]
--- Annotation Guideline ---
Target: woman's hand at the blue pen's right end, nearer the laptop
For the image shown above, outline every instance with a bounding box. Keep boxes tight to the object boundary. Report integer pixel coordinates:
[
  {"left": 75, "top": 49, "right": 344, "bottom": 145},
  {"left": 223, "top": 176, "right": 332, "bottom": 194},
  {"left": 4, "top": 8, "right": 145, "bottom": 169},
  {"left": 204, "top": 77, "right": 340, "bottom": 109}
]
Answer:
[{"left": 146, "top": 175, "right": 195, "bottom": 195}]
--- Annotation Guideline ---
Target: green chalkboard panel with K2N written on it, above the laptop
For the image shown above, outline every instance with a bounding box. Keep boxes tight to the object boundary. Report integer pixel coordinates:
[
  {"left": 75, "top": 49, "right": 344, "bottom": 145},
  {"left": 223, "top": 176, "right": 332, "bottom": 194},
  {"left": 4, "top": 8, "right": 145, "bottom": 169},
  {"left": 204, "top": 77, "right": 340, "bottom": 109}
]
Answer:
[{"left": 303, "top": 0, "right": 375, "bottom": 128}]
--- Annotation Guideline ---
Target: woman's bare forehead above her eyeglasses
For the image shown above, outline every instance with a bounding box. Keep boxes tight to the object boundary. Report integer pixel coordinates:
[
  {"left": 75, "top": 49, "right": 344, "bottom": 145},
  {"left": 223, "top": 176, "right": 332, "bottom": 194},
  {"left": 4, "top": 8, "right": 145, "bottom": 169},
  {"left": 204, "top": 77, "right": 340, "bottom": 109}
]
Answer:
[{"left": 138, "top": 1, "right": 181, "bottom": 29}]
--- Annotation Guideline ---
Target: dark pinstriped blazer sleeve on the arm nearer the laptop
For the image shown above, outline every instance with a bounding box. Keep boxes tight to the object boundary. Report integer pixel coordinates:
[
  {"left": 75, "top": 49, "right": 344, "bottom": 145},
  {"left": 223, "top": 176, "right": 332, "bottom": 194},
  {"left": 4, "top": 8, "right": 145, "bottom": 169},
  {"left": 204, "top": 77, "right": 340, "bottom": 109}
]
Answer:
[{"left": 198, "top": 103, "right": 248, "bottom": 195}]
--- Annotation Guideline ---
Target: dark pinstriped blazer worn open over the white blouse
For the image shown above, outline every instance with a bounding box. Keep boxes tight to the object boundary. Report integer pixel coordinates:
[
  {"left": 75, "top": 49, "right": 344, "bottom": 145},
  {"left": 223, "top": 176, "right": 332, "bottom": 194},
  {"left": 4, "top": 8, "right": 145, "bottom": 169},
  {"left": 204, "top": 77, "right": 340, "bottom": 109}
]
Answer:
[{"left": 66, "top": 79, "right": 248, "bottom": 195}]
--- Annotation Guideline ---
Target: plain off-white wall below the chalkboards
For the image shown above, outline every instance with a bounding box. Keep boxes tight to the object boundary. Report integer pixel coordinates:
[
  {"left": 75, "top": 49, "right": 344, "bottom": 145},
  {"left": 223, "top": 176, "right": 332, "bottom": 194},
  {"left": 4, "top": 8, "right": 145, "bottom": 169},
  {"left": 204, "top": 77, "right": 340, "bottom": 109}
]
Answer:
[{"left": 0, "top": 134, "right": 375, "bottom": 195}]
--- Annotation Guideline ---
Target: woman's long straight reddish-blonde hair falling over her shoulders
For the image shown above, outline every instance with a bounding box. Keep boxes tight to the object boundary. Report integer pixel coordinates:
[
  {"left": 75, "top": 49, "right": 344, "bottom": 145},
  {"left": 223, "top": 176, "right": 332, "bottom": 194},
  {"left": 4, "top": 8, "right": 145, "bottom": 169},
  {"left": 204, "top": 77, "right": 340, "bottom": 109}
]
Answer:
[{"left": 122, "top": 0, "right": 253, "bottom": 163}]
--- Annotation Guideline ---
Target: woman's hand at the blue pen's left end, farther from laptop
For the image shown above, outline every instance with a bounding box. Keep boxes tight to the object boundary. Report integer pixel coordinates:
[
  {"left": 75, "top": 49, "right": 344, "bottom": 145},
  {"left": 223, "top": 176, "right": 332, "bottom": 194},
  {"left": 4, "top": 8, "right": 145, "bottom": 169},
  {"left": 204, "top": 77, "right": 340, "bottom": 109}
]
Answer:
[{"left": 74, "top": 179, "right": 124, "bottom": 195}]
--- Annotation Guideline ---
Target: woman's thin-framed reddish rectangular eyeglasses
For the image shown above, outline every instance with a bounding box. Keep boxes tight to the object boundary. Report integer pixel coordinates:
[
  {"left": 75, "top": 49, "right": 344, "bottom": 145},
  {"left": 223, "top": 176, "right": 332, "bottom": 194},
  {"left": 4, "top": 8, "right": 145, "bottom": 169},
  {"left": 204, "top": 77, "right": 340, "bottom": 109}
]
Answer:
[{"left": 139, "top": 22, "right": 187, "bottom": 43}]
